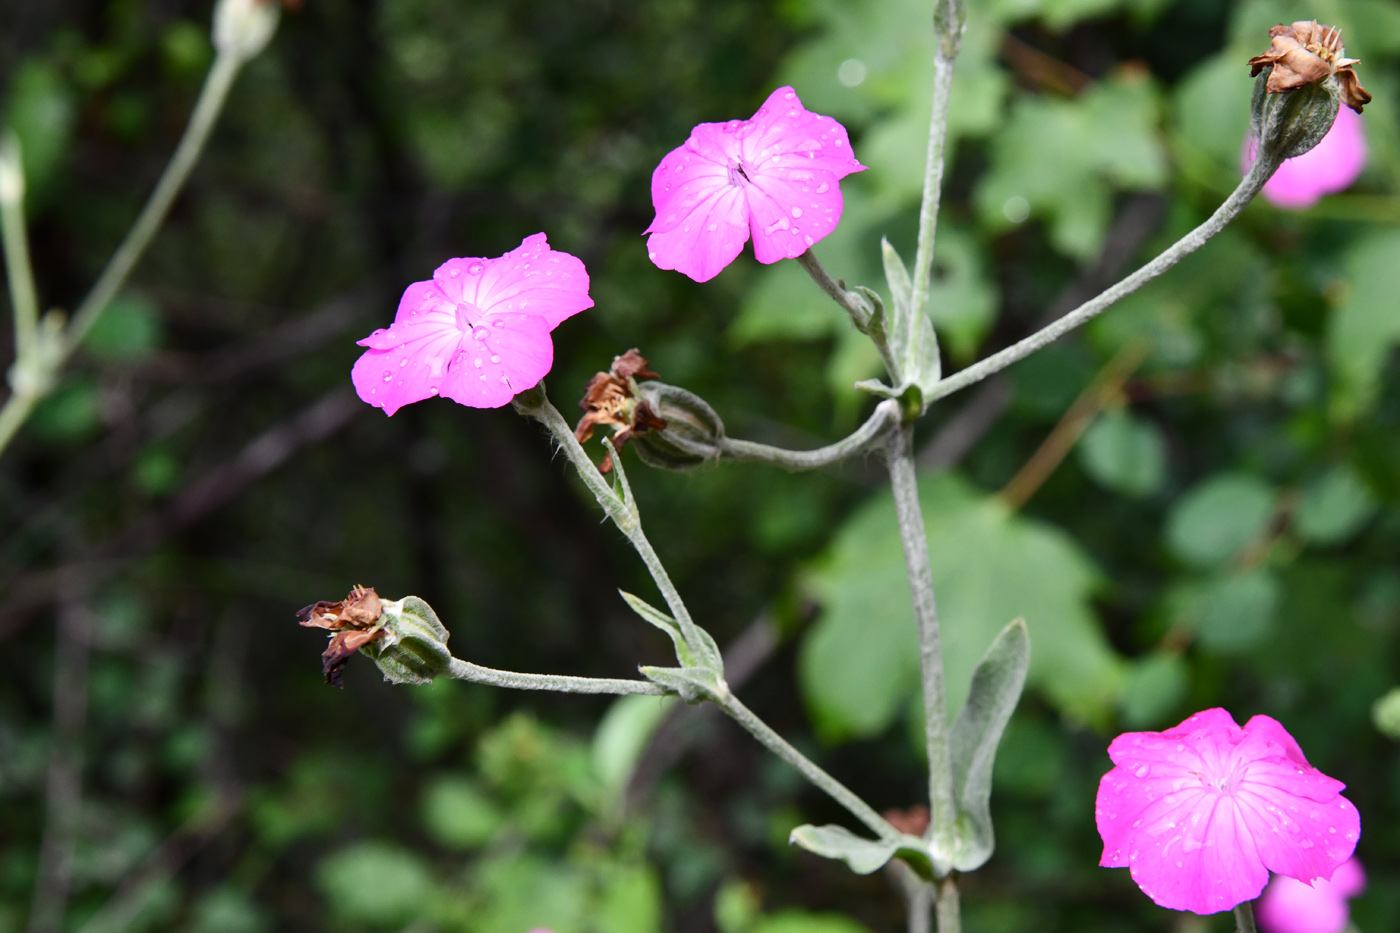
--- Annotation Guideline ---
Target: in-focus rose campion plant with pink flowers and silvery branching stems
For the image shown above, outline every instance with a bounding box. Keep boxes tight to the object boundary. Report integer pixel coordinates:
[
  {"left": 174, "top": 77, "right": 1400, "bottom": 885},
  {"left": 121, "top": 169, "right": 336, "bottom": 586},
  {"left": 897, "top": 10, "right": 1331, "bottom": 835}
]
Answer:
[{"left": 289, "top": 9, "right": 1371, "bottom": 933}]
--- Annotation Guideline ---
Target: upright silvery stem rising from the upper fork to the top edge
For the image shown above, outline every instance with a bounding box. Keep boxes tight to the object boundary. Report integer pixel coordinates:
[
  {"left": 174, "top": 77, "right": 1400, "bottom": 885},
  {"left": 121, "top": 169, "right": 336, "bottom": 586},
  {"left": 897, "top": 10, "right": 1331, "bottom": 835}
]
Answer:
[{"left": 895, "top": 0, "right": 966, "bottom": 373}]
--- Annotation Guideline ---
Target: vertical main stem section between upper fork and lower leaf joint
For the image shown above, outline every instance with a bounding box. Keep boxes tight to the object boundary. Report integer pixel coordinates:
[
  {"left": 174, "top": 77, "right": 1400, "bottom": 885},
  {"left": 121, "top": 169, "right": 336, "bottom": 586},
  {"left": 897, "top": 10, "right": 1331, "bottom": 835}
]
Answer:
[{"left": 886, "top": 424, "right": 958, "bottom": 876}]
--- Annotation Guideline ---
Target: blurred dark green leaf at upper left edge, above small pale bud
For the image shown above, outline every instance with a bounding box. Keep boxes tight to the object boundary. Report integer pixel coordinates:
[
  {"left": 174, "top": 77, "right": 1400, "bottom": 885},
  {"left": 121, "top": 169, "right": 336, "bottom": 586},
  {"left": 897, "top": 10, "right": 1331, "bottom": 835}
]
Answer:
[{"left": 4, "top": 59, "right": 77, "bottom": 202}]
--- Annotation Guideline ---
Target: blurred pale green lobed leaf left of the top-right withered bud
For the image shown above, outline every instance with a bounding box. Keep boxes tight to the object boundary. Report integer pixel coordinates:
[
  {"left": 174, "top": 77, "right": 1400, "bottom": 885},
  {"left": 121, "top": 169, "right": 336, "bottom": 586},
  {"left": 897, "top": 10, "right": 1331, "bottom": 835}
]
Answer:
[{"left": 974, "top": 71, "right": 1168, "bottom": 259}]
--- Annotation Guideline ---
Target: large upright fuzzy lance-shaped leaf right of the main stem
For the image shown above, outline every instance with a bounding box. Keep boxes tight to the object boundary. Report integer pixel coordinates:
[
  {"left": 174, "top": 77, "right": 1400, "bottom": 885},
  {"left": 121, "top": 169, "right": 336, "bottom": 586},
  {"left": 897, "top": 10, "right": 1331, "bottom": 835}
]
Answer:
[{"left": 949, "top": 619, "right": 1030, "bottom": 871}]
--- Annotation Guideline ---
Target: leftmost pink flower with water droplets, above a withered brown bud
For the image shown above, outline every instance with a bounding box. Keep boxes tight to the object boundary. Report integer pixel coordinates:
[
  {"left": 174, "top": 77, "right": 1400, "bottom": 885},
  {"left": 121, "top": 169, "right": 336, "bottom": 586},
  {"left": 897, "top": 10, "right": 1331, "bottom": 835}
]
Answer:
[{"left": 350, "top": 234, "right": 594, "bottom": 415}]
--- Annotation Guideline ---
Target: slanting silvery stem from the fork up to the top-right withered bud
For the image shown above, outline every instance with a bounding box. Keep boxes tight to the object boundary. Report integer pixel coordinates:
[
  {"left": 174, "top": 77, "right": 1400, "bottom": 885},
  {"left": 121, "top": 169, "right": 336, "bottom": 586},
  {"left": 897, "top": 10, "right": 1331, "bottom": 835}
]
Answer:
[{"left": 925, "top": 156, "right": 1278, "bottom": 402}]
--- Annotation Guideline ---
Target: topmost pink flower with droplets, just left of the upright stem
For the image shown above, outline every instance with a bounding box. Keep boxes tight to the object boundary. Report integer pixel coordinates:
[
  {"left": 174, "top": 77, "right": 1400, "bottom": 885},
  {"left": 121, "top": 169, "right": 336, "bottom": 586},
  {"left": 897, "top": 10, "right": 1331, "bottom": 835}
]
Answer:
[{"left": 644, "top": 87, "right": 865, "bottom": 282}]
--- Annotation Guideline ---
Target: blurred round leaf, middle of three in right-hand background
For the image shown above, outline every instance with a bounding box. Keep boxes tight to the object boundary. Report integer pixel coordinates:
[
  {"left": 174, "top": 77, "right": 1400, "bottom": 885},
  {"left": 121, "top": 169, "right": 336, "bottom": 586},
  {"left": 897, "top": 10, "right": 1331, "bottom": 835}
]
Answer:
[{"left": 1166, "top": 474, "right": 1275, "bottom": 567}]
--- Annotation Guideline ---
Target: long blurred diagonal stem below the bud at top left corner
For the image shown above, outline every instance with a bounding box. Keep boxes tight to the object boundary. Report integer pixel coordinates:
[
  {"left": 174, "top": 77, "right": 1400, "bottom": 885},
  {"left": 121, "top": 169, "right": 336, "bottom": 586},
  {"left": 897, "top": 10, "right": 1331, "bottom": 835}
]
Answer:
[{"left": 63, "top": 53, "right": 244, "bottom": 357}]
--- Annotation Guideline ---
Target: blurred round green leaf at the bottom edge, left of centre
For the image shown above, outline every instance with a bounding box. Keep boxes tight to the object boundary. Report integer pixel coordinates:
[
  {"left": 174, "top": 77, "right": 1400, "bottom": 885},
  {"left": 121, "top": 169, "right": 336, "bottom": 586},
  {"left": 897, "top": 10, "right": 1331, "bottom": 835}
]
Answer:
[{"left": 316, "top": 842, "right": 435, "bottom": 929}]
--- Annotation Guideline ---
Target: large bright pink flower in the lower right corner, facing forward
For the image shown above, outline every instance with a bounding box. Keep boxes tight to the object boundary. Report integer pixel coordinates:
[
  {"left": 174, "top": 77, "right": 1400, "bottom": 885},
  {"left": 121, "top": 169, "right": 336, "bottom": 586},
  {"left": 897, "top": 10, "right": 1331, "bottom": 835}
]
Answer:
[{"left": 1095, "top": 709, "right": 1361, "bottom": 913}]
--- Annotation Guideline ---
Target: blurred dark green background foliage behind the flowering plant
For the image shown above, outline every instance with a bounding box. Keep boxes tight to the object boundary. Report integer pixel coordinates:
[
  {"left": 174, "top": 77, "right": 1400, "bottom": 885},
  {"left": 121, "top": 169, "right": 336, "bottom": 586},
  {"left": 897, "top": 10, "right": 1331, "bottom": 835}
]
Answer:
[{"left": 0, "top": 0, "right": 1400, "bottom": 933}]
